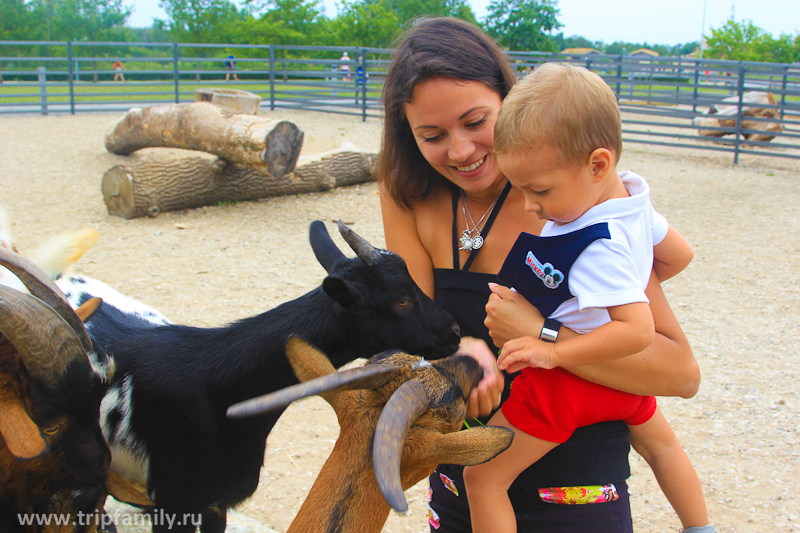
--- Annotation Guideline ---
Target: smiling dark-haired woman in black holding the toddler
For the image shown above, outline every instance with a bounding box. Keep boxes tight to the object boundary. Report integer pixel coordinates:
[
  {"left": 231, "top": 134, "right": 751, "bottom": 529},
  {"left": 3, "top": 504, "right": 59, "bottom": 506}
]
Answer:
[{"left": 379, "top": 18, "right": 699, "bottom": 532}]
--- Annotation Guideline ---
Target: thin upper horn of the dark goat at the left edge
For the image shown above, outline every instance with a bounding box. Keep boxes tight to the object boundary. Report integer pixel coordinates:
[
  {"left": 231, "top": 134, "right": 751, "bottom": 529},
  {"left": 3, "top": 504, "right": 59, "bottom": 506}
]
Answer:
[{"left": 0, "top": 248, "right": 93, "bottom": 352}]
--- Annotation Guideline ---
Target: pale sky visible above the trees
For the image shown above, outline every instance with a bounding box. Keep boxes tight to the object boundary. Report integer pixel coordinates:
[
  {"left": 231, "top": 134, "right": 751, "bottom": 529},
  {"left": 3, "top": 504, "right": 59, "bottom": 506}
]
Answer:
[{"left": 123, "top": 0, "right": 800, "bottom": 45}]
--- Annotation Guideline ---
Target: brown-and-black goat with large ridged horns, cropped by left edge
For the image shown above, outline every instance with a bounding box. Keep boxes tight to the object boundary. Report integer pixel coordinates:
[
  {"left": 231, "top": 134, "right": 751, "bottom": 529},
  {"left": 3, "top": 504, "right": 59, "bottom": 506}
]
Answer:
[{"left": 0, "top": 247, "right": 113, "bottom": 533}]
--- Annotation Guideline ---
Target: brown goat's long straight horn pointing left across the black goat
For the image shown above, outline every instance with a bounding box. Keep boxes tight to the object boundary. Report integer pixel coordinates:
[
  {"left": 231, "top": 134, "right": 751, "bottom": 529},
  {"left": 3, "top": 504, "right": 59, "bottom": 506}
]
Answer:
[{"left": 227, "top": 365, "right": 400, "bottom": 418}]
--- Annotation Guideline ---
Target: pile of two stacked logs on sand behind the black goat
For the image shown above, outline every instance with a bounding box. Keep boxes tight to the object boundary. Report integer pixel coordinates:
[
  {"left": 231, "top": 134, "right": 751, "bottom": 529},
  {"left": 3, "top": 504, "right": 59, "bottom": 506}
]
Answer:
[{"left": 101, "top": 95, "right": 377, "bottom": 218}]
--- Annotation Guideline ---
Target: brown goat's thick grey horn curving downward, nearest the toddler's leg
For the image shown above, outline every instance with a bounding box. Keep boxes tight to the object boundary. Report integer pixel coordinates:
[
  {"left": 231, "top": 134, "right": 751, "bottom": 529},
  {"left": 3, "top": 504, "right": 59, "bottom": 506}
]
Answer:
[{"left": 372, "top": 380, "right": 428, "bottom": 513}]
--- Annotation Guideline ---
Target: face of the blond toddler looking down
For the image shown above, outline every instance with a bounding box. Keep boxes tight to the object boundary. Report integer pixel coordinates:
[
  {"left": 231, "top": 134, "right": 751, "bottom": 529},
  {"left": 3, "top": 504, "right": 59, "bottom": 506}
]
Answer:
[{"left": 497, "top": 146, "right": 598, "bottom": 224}]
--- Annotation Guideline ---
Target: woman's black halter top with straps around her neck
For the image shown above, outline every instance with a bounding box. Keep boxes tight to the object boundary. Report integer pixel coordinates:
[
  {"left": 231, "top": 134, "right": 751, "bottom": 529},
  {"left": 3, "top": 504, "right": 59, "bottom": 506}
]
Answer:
[{"left": 433, "top": 184, "right": 631, "bottom": 488}]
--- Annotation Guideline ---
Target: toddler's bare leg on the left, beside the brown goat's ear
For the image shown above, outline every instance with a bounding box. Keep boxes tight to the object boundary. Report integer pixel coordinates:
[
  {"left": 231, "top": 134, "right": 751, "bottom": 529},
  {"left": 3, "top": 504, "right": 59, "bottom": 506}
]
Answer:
[{"left": 464, "top": 411, "right": 558, "bottom": 533}]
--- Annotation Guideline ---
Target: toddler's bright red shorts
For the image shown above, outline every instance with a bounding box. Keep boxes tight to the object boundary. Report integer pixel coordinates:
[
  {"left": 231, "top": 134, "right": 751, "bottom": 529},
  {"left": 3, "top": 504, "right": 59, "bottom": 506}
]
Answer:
[{"left": 502, "top": 368, "right": 656, "bottom": 443}]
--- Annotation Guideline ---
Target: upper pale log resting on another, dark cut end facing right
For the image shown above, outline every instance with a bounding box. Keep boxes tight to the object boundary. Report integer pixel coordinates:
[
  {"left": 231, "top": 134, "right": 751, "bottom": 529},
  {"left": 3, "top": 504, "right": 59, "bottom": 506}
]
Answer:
[{"left": 105, "top": 102, "right": 303, "bottom": 178}]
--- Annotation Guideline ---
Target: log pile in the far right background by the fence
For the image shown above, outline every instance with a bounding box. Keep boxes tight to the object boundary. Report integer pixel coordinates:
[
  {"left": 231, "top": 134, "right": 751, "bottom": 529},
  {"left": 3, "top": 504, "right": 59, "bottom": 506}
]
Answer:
[{"left": 692, "top": 91, "right": 783, "bottom": 141}]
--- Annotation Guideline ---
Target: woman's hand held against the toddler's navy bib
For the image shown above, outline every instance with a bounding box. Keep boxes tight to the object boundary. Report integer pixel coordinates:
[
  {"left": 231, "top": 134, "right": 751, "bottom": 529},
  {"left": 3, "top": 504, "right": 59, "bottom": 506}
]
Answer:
[{"left": 483, "top": 283, "right": 544, "bottom": 348}]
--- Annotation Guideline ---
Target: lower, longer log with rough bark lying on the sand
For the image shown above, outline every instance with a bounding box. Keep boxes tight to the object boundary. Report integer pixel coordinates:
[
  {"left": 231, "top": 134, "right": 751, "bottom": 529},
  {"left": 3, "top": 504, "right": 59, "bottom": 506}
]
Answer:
[{"left": 101, "top": 147, "right": 377, "bottom": 218}]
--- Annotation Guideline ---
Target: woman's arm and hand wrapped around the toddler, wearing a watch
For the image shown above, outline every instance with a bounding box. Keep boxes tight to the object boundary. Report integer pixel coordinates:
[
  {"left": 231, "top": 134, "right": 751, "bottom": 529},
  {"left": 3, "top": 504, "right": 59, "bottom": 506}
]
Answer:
[{"left": 486, "top": 274, "right": 700, "bottom": 398}]
